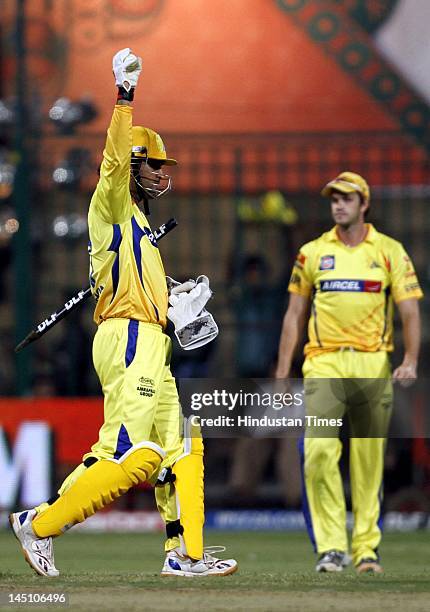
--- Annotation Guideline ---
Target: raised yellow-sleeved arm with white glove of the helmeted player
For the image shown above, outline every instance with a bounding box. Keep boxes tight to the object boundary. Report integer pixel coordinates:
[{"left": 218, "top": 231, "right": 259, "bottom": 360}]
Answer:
[{"left": 90, "top": 48, "right": 141, "bottom": 223}]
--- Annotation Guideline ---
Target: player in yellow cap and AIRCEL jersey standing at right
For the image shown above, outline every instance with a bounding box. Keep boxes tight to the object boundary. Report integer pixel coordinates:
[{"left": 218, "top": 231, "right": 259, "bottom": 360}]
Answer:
[{"left": 276, "top": 172, "right": 422, "bottom": 573}]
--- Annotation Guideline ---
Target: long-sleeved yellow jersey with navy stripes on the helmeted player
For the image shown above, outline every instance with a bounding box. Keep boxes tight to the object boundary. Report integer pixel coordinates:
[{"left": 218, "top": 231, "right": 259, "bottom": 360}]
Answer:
[{"left": 88, "top": 105, "right": 168, "bottom": 327}]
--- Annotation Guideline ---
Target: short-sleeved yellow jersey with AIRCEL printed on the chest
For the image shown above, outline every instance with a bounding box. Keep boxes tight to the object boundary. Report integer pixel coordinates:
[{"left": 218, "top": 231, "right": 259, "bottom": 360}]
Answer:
[{"left": 288, "top": 224, "right": 423, "bottom": 356}]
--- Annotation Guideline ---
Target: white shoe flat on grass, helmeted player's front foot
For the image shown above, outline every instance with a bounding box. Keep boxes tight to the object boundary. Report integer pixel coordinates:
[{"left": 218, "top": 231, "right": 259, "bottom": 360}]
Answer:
[{"left": 161, "top": 546, "right": 238, "bottom": 578}]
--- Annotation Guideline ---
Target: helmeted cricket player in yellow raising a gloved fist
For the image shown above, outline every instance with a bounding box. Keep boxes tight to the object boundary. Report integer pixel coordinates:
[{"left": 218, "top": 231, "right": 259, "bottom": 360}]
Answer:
[{"left": 10, "top": 48, "right": 237, "bottom": 576}]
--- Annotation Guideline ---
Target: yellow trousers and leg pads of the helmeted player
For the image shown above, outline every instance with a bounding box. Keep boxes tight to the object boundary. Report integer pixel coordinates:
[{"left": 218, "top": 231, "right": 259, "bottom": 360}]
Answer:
[{"left": 34, "top": 319, "right": 204, "bottom": 559}]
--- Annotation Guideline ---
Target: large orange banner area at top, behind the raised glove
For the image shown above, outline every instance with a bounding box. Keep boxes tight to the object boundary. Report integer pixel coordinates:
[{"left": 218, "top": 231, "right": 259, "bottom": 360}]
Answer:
[{"left": 4, "top": 0, "right": 397, "bottom": 134}]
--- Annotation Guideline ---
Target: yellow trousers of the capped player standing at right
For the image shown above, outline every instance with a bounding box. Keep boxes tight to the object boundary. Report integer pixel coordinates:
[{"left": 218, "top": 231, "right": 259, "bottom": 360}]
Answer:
[{"left": 300, "top": 349, "right": 392, "bottom": 564}]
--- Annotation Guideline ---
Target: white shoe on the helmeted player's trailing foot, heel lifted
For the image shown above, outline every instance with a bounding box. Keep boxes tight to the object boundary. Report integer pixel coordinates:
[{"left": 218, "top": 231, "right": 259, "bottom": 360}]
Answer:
[{"left": 9, "top": 510, "right": 60, "bottom": 578}]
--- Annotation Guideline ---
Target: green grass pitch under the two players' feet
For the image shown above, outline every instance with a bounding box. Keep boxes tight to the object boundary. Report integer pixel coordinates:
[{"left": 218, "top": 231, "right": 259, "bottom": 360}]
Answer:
[{"left": 0, "top": 532, "right": 430, "bottom": 612}]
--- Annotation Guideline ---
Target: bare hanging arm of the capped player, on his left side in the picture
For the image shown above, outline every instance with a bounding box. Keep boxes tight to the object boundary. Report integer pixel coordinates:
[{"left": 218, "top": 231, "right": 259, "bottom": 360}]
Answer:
[{"left": 275, "top": 293, "right": 310, "bottom": 378}]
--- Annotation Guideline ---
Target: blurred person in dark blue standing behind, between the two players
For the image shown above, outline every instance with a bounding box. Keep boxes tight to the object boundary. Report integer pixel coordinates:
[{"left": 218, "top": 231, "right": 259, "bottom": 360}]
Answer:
[{"left": 225, "top": 254, "right": 301, "bottom": 507}]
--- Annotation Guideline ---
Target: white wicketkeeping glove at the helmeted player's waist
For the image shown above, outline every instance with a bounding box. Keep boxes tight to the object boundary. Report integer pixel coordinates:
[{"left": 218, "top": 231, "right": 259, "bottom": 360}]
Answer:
[{"left": 166, "top": 275, "right": 218, "bottom": 351}]
